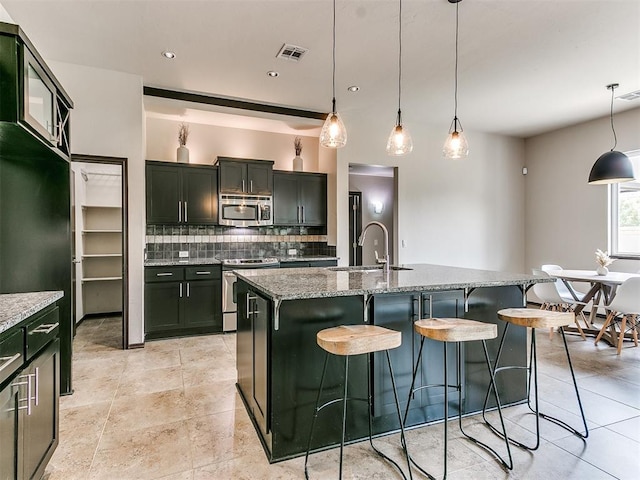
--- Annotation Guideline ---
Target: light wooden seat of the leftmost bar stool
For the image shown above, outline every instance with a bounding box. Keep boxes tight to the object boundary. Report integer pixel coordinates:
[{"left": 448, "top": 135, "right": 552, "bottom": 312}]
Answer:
[{"left": 316, "top": 325, "right": 402, "bottom": 355}]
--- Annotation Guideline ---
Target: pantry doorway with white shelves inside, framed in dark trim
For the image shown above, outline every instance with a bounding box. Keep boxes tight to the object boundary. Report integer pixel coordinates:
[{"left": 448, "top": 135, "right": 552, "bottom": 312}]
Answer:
[{"left": 71, "top": 155, "right": 128, "bottom": 349}]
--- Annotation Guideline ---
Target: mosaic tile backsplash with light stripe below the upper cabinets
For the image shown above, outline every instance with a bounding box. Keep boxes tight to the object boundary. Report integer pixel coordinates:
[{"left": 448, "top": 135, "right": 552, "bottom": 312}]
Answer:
[{"left": 146, "top": 225, "right": 336, "bottom": 260}]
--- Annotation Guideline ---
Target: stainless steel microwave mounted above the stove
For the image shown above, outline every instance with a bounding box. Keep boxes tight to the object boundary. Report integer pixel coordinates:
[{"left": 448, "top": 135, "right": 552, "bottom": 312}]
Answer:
[{"left": 218, "top": 195, "right": 273, "bottom": 227}]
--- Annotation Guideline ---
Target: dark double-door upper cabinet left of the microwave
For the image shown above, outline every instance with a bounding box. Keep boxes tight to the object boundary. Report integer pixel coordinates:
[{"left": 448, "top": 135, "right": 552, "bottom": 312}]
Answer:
[{"left": 146, "top": 161, "right": 218, "bottom": 225}]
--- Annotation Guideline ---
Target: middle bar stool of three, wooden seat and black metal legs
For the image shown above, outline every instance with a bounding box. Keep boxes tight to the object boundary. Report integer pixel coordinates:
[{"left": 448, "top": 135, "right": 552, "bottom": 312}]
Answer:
[{"left": 404, "top": 318, "right": 513, "bottom": 480}]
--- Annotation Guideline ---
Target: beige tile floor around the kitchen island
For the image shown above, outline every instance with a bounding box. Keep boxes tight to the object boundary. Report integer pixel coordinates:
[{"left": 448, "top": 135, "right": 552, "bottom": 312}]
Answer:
[{"left": 45, "top": 318, "right": 640, "bottom": 480}]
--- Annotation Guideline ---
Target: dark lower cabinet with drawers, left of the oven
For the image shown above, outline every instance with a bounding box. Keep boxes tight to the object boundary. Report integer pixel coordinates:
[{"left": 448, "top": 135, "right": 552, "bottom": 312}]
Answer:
[{"left": 144, "top": 265, "right": 222, "bottom": 340}]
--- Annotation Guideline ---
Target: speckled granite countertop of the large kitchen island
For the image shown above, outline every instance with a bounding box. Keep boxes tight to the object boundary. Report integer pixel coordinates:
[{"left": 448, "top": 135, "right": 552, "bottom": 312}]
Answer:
[{"left": 236, "top": 264, "right": 554, "bottom": 300}]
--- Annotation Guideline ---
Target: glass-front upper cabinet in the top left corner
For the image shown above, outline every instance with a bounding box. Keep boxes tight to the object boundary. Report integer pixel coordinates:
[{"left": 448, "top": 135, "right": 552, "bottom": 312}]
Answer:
[{"left": 0, "top": 22, "right": 73, "bottom": 157}]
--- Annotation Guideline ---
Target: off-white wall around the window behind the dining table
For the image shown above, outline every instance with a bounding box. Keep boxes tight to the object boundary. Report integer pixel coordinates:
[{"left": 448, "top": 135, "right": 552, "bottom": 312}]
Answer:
[{"left": 524, "top": 108, "right": 640, "bottom": 272}]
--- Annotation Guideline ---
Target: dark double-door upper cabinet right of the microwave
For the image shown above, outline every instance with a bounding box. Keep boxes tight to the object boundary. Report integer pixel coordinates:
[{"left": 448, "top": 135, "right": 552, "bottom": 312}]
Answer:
[{"left": 273, "top": 172, "right": 327, "bottom": 226}]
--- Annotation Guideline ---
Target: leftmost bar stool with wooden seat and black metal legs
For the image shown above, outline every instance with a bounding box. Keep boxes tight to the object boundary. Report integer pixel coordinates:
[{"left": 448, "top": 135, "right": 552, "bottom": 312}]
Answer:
[{"left": 304, "top": 325, "right": 413, "bottom": 480}]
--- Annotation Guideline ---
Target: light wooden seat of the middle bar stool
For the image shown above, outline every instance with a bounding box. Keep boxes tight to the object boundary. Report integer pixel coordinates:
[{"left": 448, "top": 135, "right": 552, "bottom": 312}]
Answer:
[{"left": 413, "top": 318, "right": 498, "bottom": 342}]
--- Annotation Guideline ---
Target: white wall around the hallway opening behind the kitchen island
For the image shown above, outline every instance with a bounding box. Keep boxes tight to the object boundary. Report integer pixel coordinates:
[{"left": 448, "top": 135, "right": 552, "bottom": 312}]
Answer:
[{"left": 336, "top": 111, "right": 524, "bottom": 272}]
